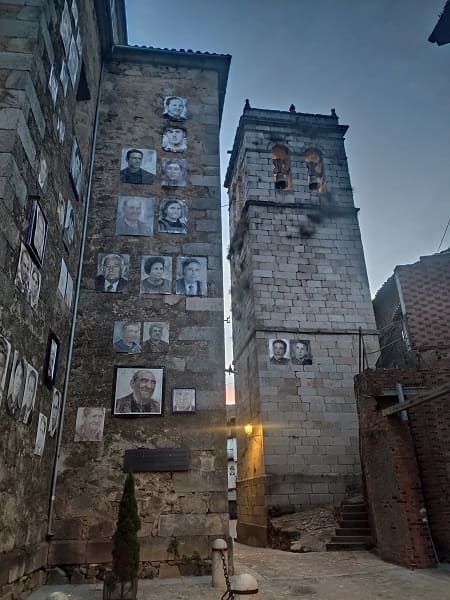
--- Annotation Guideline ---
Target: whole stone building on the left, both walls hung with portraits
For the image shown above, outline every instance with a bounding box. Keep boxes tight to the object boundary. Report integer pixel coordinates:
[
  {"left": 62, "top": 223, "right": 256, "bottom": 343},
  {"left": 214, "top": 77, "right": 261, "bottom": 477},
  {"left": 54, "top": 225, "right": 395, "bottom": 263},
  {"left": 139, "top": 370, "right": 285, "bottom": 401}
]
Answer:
[{"left": 0, "top": 0, "right": 230, "bottom": 597}]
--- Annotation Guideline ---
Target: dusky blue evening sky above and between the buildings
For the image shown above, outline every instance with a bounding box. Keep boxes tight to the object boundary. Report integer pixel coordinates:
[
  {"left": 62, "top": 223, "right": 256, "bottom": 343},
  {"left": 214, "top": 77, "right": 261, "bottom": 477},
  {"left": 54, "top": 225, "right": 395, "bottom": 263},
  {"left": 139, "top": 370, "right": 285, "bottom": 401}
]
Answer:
[{"left": 126, "top": 0, "right": 450, "bottom": 404}]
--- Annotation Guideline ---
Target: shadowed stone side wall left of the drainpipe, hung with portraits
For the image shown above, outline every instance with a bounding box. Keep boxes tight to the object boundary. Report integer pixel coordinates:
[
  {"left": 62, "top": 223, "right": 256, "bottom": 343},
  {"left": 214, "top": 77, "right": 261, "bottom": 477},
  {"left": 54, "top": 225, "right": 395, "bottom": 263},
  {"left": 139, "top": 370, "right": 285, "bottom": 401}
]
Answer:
[{"left": 0, "top": 0, "right": 100, "bottom": 597}]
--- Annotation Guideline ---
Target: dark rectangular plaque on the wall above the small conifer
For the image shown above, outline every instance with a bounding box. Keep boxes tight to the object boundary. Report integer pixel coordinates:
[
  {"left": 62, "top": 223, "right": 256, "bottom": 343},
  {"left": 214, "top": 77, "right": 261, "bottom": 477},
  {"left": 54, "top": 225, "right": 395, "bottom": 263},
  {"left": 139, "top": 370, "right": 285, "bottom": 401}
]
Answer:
[{"left": 123, "top": 448, "right": 189, "bottom": 473}]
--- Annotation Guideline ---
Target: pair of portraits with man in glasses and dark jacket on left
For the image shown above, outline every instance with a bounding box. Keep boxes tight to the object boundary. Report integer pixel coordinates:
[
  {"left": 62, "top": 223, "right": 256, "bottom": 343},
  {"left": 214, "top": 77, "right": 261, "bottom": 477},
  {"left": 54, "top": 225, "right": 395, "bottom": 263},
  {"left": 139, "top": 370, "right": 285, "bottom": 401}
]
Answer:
[{"left": 120, "top": 148, "right": 187, "bottom": 187}]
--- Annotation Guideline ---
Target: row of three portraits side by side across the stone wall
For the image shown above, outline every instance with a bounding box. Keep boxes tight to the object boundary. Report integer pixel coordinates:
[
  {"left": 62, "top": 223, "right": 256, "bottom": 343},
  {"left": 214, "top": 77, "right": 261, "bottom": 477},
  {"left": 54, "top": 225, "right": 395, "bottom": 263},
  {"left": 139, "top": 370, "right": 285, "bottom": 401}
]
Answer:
[{"left": 95, "top": 253, "right": 207, "bottom": 296}]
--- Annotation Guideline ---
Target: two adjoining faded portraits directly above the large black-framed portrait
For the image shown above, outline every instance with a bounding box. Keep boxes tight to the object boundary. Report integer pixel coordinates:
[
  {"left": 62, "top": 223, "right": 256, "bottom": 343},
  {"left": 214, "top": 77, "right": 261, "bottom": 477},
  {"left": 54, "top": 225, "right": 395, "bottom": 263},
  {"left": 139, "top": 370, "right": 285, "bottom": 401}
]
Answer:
[{"left": 113, "top": 321, "right": 169, "bottom": 354}]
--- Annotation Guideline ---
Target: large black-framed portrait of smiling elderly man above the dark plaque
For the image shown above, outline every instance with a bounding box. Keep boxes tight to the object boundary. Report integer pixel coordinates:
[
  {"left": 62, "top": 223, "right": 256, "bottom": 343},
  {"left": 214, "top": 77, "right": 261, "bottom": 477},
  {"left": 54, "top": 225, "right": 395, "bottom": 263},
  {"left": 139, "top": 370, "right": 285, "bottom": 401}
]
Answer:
[{"left": 112, "top": 367, "right": 164, "bottom": 417}]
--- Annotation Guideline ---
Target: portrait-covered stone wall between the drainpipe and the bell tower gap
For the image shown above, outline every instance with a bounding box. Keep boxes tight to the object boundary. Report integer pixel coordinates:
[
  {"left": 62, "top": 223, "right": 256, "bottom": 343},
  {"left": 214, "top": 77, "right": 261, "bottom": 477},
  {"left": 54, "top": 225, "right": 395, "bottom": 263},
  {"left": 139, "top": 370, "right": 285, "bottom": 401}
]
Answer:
[{"left": 50, "top": 48, "right": 228, "bottom": 580}]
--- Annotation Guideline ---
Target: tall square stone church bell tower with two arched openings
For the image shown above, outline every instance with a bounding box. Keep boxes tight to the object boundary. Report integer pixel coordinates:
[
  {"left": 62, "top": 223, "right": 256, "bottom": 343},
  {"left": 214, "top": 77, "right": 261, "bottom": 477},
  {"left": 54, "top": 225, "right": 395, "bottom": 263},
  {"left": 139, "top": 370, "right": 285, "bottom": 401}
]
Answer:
[{"left": 225, "top": 103, "right": 377, "bottom": 545}]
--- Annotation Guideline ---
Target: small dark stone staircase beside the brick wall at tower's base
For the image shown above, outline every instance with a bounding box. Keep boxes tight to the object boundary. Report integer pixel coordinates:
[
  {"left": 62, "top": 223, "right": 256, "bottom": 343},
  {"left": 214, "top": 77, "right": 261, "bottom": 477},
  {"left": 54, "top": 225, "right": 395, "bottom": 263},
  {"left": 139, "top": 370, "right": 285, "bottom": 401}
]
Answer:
[{"left": 326, "top": 501, "right": 373, "bottom": 551}]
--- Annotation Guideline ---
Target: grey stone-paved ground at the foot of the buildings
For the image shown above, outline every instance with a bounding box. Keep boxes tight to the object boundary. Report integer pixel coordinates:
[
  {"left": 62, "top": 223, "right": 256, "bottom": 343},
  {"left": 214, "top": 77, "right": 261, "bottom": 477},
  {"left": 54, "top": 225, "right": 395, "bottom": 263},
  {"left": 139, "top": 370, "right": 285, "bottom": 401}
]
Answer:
[{"left": 30, "top": 544, "right": 450, "bottom": 600}]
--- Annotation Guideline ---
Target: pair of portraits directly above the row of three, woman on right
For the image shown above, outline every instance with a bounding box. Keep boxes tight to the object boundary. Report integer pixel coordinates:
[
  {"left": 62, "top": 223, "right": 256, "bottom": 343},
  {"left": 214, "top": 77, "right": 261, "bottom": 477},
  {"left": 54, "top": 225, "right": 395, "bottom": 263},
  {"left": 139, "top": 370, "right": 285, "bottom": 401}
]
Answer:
[{"left": 116, "top": 196, "right": 187, "bottom": 236}]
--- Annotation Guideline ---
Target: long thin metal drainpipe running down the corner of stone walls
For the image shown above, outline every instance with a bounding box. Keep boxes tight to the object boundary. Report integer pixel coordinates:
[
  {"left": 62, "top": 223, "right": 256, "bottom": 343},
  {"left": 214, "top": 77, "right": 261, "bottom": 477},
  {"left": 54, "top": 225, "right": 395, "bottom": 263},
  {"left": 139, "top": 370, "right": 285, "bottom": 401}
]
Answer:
[{"left": 47, "top": 62, "right": 103, "bottom": 538}]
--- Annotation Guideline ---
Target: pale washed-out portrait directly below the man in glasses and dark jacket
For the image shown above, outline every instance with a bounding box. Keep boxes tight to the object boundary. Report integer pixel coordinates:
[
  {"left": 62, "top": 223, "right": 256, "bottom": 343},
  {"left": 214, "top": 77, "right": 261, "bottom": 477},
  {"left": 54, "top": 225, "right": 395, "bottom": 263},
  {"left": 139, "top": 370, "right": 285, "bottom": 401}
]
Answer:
[{"left": 116, "top": 196, "right": 154, "bottom": 236}]
